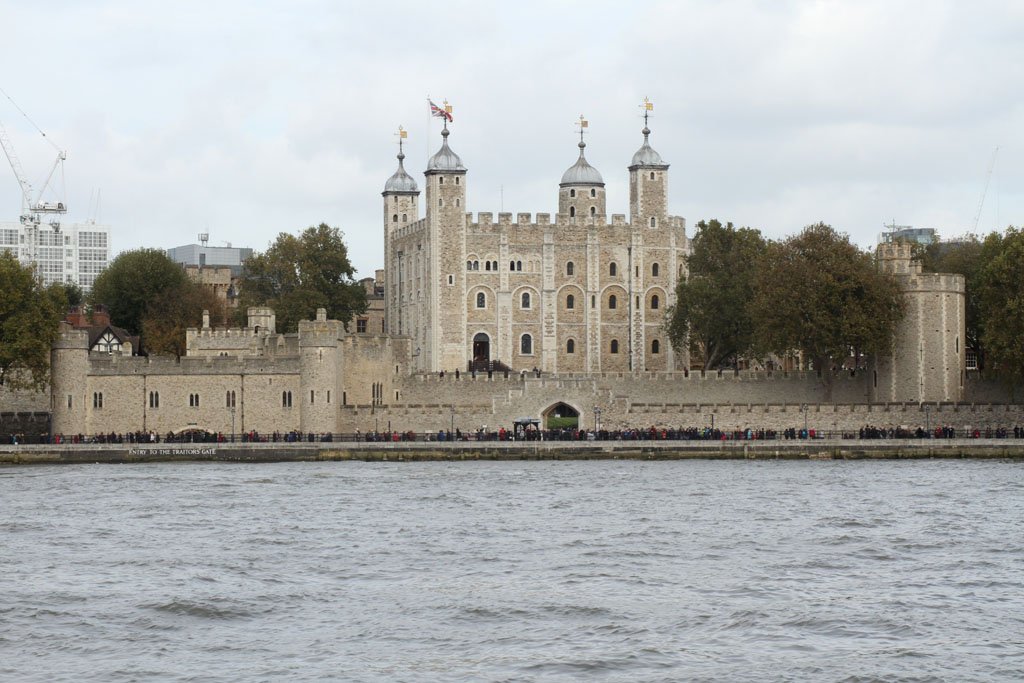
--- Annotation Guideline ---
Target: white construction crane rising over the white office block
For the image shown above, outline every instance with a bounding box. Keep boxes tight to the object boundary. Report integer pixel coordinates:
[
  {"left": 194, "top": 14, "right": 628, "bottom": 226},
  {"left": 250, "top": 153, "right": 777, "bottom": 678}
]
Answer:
[{"left": 0, "top": 90, "right": 68, "bottom": 262}]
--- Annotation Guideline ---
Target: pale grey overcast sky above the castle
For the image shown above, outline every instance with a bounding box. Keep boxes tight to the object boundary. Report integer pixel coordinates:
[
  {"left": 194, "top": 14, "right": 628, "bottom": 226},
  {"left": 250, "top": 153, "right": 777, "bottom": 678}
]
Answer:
[{"left": 0, "top": 0, "right": 1024, "bottom": 275}]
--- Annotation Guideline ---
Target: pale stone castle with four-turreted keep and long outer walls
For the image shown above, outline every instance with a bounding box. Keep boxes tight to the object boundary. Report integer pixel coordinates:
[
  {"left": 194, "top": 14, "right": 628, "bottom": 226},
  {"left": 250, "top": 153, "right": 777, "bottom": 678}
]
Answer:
[{"left": 41, "top": 116, "right": 1019, "bottom": 434}]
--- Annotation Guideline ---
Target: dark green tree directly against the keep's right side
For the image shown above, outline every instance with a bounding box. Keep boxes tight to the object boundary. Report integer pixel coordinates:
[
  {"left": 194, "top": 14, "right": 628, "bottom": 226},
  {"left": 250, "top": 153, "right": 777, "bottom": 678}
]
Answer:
[{"left": 668, "top": 220, "right": 766, "bottom": 370}]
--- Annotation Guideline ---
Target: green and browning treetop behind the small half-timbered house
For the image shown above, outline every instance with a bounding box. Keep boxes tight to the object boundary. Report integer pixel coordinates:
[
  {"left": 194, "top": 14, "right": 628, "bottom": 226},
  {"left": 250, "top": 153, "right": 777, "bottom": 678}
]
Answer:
[{"left": 89, "top": 249, "right": 223, "bottom": 355}]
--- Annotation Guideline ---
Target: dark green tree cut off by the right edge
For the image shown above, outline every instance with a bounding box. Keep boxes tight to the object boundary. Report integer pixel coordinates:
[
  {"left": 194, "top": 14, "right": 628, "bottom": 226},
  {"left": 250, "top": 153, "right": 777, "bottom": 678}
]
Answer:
[{"left": 978, "top": 227, "right": 1024, "bottom": 385}]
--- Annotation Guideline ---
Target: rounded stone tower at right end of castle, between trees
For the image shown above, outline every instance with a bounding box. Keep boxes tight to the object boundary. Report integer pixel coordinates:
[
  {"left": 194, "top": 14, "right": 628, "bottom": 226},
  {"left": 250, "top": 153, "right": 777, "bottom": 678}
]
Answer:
[{"left": 871, "top": 242, "right": 967, "bottom": 402}]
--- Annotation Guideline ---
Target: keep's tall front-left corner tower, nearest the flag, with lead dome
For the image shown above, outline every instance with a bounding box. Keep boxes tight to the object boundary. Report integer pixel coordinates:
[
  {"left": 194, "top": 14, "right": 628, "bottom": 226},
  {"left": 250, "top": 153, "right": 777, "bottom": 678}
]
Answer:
[{"left": 422, "top": 120, "right": 467, "bottom": 371}]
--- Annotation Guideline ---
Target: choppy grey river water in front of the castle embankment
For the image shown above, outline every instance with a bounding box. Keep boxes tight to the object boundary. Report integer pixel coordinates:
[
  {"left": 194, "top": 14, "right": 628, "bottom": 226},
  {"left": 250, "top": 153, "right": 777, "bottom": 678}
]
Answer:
[{"left": 0, "top": 461, "right": 1024, "bottom": 683}]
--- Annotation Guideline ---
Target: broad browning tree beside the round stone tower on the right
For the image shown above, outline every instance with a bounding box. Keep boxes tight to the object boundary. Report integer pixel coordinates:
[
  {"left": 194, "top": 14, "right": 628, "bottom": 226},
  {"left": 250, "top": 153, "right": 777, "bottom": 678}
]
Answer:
[{"left": 752, "top": 223, "right": 903, "bottom": 399}]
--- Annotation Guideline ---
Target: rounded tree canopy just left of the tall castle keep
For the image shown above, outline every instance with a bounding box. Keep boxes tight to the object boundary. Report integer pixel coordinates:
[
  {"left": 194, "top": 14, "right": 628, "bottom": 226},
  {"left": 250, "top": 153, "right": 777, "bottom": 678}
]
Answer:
[{"left": 240, "top": 223, "right": 367, "bottom": 332}]
